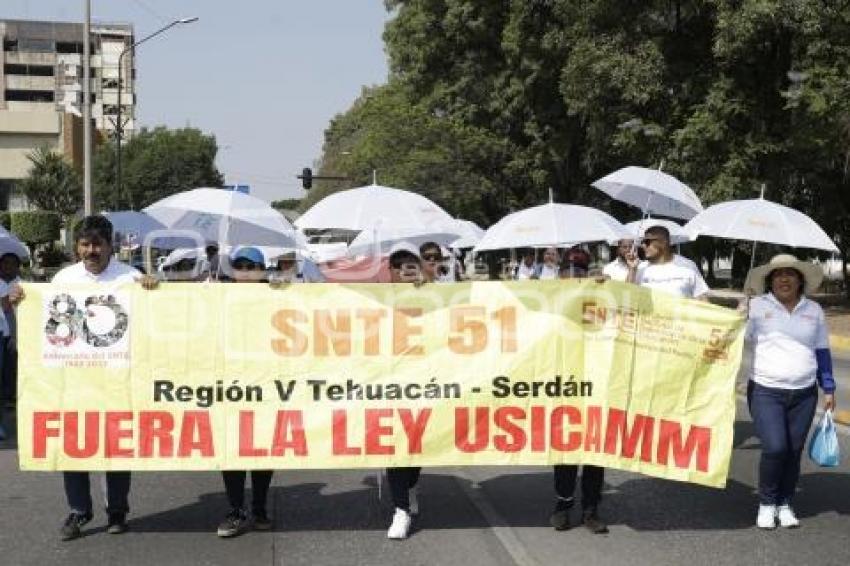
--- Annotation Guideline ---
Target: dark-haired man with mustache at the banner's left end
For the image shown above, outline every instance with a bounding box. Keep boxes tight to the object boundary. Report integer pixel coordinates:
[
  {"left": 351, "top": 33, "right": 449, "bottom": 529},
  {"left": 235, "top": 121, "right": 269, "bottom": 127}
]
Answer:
[{"left": 10, "top": 215, "right": 156, "bottom": 540}]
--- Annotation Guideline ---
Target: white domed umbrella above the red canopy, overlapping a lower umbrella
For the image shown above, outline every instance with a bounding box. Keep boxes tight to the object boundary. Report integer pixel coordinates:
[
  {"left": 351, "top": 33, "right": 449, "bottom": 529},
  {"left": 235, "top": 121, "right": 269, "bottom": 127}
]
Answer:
[{"left": 295, "top": 184, "right": 453, "bottom": 230}]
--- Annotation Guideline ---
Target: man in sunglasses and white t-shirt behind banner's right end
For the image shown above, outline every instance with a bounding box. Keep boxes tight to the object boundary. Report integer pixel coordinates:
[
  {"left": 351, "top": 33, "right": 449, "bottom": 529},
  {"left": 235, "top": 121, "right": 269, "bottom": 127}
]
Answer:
[{"left": 626, "top": 226, "right": 709, "bottom": 300}]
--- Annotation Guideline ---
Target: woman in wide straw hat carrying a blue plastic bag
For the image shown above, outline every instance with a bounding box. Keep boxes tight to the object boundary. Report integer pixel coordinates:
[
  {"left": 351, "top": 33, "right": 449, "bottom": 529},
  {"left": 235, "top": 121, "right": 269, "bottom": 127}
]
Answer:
[{"left": 745, "top": 254, "right": 835, "bottom": 529}]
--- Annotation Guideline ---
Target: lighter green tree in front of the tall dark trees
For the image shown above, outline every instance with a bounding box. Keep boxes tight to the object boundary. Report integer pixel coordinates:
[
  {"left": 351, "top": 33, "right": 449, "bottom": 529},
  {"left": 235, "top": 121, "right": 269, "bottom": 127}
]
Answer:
[{"left": 310, "top": 83, "right": 516, "bottom": 222}]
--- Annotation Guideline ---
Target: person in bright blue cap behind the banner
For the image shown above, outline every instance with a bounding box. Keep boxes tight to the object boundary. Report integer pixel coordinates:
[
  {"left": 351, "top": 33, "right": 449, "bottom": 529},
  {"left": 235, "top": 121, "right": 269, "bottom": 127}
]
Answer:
[{"left": 216, "top": 247, "right": 273, "bottom": 538}]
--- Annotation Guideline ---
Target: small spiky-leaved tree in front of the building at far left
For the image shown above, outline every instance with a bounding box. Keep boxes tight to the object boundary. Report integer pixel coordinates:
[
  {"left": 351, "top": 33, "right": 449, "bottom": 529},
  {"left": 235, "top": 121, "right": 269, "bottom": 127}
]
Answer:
[{"left": 19, "top": 147, "right": 83, "bottom": 223}]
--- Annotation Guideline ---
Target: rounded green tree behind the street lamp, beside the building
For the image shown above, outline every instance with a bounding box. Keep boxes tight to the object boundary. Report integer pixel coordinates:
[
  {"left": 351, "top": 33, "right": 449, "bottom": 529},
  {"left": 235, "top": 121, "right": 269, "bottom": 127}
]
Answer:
[{"left": 93, "top": 126, "right": 224, "bottom": 210}]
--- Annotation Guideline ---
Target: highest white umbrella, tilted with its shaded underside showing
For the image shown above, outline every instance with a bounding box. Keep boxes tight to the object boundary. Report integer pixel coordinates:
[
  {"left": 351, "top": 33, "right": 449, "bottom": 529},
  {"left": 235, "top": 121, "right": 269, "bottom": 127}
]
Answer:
[{"left": 591, "top": 166, "right": 702, "bottom": 220}]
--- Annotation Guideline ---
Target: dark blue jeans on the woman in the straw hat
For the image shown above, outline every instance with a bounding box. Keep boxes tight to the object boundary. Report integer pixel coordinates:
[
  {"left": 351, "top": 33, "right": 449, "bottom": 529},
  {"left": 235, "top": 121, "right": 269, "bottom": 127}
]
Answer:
[{"left": 747, "top": 381, "right": 818, "bottom": 505}]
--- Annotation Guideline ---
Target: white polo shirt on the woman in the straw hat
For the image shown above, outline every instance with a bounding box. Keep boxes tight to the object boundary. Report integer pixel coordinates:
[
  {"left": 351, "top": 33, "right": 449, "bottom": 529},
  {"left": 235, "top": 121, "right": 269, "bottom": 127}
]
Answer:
[{"left": 746, "top": 293, "right": 829, "bottom": 389}]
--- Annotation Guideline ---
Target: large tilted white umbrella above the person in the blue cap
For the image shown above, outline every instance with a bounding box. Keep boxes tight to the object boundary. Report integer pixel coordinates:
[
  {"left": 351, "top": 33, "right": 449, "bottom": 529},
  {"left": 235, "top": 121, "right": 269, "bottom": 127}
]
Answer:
[{"left": 144, "top": 188, "right": 306, "bottom": 248}]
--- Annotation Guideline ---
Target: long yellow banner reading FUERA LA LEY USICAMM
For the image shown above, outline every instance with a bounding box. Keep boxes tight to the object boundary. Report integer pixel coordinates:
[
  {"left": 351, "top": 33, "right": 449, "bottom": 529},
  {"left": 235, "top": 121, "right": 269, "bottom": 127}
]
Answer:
[{"left": 18, "top": 280, "right": 743, "bottom": 486}]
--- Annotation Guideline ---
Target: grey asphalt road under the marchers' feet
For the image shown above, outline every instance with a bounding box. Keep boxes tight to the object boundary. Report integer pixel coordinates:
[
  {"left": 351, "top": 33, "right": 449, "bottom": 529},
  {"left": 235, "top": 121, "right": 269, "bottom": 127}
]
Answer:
[{"left": 0, "top": 403, "right": 850, "bottom": 566}]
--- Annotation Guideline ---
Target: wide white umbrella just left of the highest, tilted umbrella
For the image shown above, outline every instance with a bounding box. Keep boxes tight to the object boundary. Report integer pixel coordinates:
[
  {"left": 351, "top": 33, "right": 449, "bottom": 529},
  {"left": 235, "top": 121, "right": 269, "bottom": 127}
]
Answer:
[{"left": 474, "top": 203, "right": 634, "bottom": 252}]
